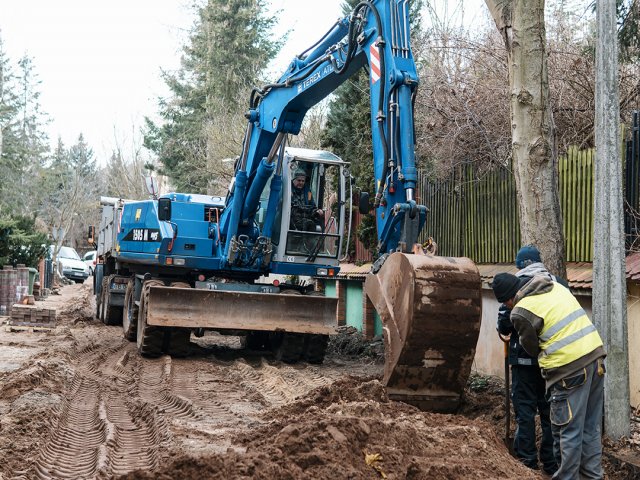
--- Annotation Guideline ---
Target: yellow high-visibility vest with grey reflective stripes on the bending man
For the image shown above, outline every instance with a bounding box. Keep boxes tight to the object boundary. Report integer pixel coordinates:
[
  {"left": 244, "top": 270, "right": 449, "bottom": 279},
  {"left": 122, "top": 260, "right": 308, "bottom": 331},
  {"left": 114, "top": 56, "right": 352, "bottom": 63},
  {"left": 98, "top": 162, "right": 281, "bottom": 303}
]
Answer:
[{"left": 514, "top": 282, "right": 602, "bottom": 369}]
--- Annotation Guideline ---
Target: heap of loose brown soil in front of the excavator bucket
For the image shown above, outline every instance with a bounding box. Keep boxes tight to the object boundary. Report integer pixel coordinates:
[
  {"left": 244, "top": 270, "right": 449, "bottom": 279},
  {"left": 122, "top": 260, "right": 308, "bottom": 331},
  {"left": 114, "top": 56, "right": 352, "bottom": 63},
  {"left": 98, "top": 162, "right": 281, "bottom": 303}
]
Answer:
[{"left": 121, "top": 378, "right": 542, "bottom": 480}]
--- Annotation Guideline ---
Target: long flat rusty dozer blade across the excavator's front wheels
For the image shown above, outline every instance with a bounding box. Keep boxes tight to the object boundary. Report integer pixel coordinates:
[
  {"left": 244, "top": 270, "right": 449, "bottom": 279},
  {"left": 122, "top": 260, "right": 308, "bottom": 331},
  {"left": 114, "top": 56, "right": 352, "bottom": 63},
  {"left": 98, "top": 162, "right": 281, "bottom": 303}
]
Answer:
[{"left": 146, "top": 286, "right": 338, "bottom": 335}]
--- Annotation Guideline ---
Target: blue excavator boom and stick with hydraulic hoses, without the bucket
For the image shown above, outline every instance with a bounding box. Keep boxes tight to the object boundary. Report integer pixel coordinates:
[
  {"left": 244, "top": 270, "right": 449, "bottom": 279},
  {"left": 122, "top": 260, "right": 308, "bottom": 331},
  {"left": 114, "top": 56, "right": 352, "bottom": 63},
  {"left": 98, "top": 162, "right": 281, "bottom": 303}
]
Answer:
[{"left": 221, "top": 0, "right": 426, "bottom": 262}]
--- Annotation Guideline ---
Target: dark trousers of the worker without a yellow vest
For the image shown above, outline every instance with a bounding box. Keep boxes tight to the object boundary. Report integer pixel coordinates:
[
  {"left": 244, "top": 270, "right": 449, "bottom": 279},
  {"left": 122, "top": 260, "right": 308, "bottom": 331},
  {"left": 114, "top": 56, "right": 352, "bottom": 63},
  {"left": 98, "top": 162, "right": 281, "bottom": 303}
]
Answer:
[{"left": 511, "top": 365, "right": 558, "bottom": 474}]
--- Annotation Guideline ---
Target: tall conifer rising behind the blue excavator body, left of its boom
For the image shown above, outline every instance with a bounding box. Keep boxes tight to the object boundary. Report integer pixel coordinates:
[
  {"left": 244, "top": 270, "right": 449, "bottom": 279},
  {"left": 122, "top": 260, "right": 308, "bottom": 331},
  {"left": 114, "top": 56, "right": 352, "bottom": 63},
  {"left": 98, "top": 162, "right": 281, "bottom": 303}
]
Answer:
[{"left": 144, "top": 0, "right": 279, "bottom": 193}]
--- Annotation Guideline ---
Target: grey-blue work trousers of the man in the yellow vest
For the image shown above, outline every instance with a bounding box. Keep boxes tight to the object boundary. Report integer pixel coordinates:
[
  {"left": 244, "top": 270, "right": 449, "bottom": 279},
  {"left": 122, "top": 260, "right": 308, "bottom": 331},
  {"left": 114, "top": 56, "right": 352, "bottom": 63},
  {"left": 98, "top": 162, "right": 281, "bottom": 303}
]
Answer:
[{"left": 550, "top": 359, "right": 604, "bottom": 480}]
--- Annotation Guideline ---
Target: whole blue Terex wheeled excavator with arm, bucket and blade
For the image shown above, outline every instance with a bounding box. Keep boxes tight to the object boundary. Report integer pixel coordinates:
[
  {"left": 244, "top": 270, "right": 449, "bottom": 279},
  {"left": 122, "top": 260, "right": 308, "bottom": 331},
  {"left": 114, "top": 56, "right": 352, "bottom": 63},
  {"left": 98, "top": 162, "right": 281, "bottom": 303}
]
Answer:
[{"left": 92, "top": 0, "right": 481, "bottom": 411}]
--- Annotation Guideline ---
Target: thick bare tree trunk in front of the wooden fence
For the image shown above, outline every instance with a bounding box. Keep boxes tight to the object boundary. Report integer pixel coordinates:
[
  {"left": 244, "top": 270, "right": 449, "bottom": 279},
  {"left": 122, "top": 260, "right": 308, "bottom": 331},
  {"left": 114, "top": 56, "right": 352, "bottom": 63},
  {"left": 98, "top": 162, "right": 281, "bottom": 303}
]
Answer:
[{"left": 485, "top": 0, "right": 566, "bottom": 277}]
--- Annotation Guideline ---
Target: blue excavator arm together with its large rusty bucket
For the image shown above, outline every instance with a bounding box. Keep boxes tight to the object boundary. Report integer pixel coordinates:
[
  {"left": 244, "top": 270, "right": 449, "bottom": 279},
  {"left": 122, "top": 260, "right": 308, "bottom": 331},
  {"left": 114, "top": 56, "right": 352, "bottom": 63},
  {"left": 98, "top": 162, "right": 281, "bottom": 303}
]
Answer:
[{"left": 220, "top": 0, "right": 481, "bottom": 411}]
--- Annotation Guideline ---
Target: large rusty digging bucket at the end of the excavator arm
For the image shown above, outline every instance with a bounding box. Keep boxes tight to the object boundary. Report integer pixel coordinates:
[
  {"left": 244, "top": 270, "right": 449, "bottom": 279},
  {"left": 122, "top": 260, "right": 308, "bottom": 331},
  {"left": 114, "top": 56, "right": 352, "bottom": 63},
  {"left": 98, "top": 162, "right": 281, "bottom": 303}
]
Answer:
[{"left": 365, "top": 253, "right": 482, "bottom": 412}]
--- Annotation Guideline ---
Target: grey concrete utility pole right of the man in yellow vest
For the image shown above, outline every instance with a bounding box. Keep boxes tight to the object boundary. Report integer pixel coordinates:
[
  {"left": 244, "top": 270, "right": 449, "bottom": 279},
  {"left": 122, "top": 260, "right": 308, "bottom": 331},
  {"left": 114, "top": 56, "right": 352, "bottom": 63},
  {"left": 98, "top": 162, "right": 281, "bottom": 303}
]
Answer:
[{"left": 593, "top": 0, "right": 631, "bottom": 440}]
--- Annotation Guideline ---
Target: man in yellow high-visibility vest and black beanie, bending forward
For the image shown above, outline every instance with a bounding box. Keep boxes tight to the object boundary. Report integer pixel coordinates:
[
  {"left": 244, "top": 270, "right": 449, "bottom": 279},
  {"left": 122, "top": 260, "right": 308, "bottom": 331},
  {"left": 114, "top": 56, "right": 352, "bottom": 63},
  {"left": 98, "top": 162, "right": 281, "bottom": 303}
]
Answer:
[{"left": 491, "top": 273, "right": 606, "bottom": 480}]
